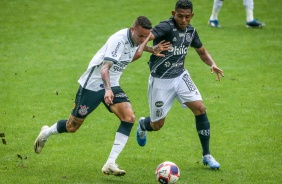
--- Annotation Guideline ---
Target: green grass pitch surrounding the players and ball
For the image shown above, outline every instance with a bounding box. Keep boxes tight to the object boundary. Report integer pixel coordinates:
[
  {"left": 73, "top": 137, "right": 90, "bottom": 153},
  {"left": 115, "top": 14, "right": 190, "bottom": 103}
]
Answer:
[{"left": 0, "top": 0, "right": 282, "bottom": 184}]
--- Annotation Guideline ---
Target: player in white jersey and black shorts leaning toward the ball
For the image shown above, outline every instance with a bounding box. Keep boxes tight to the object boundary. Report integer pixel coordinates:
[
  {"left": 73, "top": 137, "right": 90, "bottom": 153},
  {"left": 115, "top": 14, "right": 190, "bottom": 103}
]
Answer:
[{"left": 34, "top": 16, "right": 172, "bottom": 176}]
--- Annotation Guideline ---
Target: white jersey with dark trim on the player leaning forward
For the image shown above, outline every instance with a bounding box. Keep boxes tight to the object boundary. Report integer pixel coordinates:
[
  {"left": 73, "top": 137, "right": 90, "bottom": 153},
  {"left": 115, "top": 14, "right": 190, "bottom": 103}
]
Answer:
[{"left": 78, "top": 28, "right": 138, "bottom": 91}]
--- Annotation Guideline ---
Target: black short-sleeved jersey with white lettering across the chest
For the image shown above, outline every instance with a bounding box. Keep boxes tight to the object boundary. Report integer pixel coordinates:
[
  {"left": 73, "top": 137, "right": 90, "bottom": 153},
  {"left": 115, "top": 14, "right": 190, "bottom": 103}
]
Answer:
[{"left": 149, "top": 18, "right": 202, "bottom": 79}]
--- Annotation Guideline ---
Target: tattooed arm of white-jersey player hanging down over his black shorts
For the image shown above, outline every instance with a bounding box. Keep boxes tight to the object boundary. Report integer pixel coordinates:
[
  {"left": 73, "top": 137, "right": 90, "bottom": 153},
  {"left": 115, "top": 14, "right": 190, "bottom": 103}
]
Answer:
[{"left": 100, "top": 60, "right": 114, "bottom": 105}]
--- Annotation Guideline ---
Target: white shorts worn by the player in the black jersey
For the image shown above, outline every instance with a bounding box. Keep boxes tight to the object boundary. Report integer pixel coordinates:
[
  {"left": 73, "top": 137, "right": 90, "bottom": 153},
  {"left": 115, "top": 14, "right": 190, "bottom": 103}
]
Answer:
[{"left": 148, "top": 70, "right": 202, "bottom": 122}]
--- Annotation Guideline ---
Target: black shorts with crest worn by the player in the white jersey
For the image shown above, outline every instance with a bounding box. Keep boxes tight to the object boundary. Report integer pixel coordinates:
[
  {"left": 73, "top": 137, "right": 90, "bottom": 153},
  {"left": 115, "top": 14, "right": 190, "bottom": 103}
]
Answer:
[{"left": 71, "top": 86, "right": 130, "bottom": 118}]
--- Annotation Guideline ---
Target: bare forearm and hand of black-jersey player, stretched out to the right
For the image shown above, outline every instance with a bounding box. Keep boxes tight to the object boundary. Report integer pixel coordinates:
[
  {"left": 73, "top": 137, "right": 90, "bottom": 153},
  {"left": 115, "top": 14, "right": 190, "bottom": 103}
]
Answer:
[{"left": 195, "top": 46, "right": 224, "bottom": 81}]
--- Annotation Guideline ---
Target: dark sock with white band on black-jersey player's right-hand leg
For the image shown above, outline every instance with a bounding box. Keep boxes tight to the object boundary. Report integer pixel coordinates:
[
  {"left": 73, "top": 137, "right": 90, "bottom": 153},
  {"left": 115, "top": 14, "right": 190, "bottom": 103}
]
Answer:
[{"left": 195, "top": 113, "right": 210, "bottom": 155}]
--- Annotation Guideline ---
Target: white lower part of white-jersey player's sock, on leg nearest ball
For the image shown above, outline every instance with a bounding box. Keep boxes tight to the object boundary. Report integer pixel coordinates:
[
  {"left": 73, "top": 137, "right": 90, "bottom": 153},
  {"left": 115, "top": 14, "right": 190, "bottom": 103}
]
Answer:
[{"left": 106, "top": 132, "right": 128, "bottom": 164}]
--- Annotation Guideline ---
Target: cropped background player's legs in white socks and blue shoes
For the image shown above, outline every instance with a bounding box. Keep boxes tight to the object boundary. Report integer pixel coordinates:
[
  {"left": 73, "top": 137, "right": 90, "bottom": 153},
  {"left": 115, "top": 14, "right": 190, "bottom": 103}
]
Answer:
[{"left": 208, "top": 0, "right": 265, "bottom": 28}]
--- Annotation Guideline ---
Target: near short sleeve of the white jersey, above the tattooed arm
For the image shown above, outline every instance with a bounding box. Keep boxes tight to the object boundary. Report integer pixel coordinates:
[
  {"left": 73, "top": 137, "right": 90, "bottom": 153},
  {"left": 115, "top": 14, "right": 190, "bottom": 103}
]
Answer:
[{"left": 104, "top": 37, "right": 125, "bottom": 64}]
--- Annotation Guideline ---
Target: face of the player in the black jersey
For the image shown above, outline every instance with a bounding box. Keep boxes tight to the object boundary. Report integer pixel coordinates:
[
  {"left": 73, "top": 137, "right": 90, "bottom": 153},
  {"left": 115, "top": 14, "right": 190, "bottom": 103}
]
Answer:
[{"left": 172, "top": 9, "right": 194, "bottom": 30}]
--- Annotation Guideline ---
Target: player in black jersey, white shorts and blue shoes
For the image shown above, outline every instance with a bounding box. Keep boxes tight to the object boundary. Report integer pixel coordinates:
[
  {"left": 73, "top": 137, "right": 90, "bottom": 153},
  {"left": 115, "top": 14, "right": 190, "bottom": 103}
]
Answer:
[{"left": 136, "top": 0, "right": 224, "bottom": 169}]
